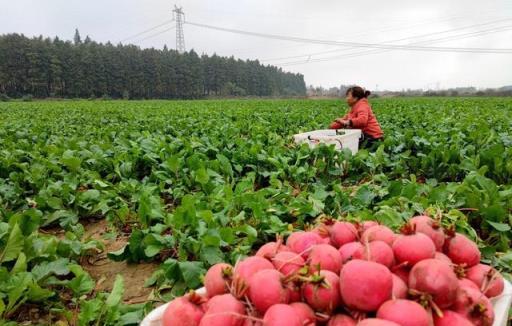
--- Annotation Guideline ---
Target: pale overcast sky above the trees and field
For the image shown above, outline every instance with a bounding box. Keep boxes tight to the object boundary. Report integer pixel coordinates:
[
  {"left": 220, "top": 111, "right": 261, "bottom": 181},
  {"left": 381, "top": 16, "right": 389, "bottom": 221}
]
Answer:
[{"left": 0, "top": 0, "right": 512, "bottom": 90}]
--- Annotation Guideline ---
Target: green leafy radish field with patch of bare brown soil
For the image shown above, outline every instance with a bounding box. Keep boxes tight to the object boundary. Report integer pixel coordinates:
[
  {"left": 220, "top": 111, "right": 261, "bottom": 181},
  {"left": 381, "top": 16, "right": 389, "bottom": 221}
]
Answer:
[{"left": 0, "top": 98, "right": 512, "bottom": 325}]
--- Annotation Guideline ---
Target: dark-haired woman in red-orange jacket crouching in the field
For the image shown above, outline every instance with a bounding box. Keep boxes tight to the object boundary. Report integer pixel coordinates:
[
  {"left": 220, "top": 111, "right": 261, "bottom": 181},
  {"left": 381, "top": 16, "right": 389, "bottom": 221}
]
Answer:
[{"left": 330, "top": 86, "right": 384, "bottom": 148}]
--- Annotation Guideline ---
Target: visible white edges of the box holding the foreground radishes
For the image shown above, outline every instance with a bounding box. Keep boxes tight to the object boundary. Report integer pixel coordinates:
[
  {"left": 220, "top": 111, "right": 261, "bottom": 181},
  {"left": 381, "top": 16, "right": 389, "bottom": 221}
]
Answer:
[{"left": 140, "top": 281, "right": 512, "bottom": 326}]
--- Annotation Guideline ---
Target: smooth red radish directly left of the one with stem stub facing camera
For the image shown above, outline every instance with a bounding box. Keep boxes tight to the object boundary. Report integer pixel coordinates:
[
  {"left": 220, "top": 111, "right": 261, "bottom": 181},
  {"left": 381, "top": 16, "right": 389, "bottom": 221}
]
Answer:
[{"left": 248, "top": 269, "right": 290, "bottom": 314}]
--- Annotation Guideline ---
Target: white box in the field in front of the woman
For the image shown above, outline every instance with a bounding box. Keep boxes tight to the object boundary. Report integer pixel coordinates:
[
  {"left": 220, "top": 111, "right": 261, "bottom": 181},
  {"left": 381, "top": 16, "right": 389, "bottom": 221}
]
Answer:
[{"left": 293, "top": 129, "right": 362, "bottom": 154}]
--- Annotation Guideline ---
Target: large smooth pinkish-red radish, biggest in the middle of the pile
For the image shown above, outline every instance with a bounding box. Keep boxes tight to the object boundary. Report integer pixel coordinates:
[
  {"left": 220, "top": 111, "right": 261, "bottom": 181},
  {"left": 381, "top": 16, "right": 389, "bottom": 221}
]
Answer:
[{"left": 340, "top": 259, "right": 393, "bottom": 311}]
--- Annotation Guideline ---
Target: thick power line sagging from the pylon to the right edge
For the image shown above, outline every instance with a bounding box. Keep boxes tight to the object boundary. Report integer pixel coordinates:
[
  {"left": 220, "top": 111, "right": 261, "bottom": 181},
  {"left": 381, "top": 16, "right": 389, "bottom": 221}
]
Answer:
[{"left": 186, "top": 21, "right": 512, "bottom": 54}]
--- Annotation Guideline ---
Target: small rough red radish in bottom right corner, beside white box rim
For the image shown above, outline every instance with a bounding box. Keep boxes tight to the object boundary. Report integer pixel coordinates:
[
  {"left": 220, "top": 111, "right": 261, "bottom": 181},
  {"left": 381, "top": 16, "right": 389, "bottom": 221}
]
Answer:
[{"left": 453, "top": 287, "right": 494, "bottom": 326}]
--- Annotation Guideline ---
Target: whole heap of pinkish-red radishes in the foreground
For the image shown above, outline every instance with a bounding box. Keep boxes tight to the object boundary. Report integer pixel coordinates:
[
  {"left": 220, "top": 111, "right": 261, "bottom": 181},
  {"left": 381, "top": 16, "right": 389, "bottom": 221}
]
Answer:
[{"left": 162, "top": 216, "right": 504, "bottom": 326}]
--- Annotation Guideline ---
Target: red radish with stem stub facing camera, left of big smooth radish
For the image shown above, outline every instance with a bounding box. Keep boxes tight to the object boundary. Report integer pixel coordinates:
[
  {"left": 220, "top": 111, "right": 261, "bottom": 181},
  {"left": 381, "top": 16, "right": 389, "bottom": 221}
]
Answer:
[{"left": 302, "top": 271, "right": 340, "bottom": 313}]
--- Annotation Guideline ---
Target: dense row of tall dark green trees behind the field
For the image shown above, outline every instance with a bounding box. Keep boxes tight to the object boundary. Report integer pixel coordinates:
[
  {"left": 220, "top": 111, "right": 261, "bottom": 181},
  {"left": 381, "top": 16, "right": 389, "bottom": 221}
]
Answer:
[{"left": 0, "top": 31, "right": 306, "bottom": 99}]
